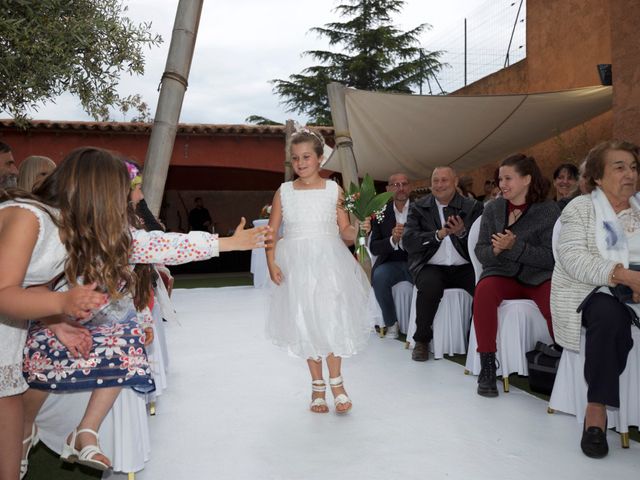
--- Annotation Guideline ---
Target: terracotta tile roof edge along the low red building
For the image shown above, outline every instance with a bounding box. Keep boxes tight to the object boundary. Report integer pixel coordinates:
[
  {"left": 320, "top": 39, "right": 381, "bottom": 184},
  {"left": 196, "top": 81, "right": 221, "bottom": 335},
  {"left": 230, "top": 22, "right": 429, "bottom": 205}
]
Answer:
[{"left": 0, "top": 119, "right": 333, "bottom": 137}]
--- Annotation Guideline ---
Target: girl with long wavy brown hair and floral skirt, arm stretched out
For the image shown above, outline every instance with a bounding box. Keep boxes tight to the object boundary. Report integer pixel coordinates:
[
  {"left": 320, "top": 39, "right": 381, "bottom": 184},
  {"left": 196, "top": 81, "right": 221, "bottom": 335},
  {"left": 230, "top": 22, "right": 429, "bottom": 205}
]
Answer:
[{"left": 0, "top": 147, "right": 265, "bottom": 474}]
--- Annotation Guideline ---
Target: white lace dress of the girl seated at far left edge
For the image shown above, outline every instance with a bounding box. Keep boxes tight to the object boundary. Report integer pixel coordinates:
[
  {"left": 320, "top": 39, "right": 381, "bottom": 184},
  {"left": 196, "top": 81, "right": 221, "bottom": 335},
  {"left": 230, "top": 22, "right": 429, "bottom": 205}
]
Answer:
[{"left": 0, "top": 201, "right": 66, "bottom": 397}]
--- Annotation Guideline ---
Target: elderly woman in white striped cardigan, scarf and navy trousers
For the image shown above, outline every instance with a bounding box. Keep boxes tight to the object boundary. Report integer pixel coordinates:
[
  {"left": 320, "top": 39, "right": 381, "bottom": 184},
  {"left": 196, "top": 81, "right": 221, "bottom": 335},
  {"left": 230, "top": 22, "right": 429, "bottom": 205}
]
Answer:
[{"left": 551, "top": 140, "right": 640, "bottom": 458}]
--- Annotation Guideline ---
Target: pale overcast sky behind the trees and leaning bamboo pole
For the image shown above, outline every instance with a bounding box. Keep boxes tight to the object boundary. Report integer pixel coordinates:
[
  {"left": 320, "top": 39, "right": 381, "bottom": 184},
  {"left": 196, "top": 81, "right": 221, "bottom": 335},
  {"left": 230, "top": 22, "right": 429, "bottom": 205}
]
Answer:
[{"left": 8, "top": 0, "right": 496, "bottom": 124}]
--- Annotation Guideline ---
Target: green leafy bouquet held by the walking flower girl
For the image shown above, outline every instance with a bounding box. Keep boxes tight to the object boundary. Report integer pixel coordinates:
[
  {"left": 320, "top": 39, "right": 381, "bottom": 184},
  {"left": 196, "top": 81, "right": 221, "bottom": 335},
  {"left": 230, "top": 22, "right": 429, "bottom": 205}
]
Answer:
[{"left": 344, "top": 174, "right": 393, "bottom": 265}]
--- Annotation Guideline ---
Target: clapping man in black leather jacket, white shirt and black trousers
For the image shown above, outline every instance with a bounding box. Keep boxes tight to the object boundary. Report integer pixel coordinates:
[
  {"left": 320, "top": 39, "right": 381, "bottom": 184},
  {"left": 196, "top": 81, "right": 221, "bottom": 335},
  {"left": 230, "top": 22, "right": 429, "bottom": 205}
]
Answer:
[{"left": 402, "top": 167, "right": 483, "bottom": 362}]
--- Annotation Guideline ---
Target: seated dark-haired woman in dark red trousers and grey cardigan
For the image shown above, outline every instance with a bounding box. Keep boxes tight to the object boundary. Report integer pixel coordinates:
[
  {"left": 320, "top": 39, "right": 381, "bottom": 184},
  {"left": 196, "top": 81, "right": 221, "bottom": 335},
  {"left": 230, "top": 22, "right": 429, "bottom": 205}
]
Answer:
[{"left": 473, "top": 154, "right": 560, "bottom": 397}]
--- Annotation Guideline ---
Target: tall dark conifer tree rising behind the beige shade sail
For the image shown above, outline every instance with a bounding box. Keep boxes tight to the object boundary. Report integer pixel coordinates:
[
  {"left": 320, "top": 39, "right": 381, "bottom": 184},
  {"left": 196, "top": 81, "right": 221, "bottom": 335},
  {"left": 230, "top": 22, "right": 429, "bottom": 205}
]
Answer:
[{"left": 272, "top": 0, "right": 442, "bottom": 125}]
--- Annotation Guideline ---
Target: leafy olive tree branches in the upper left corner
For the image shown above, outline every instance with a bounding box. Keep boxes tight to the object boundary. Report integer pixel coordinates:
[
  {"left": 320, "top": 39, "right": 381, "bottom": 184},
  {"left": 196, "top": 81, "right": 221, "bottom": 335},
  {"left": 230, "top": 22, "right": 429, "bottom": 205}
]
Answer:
[{"left": 0, "top": 0, "right": 162, "bottom": 122}]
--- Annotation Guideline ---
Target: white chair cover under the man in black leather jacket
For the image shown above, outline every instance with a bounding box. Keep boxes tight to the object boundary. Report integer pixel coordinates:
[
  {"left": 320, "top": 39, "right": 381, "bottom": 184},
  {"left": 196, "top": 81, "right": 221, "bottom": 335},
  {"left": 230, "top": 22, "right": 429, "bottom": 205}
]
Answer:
[{"left": 407, "top": 287, "right": 473, "bottom": 359}]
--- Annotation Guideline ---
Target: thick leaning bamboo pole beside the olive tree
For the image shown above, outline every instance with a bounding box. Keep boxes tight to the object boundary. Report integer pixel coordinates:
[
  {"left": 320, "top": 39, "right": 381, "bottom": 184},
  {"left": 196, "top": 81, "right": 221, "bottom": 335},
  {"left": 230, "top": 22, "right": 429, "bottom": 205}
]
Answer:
[{"left": 144, "top": 0, "right": 204, "bottom": 215}]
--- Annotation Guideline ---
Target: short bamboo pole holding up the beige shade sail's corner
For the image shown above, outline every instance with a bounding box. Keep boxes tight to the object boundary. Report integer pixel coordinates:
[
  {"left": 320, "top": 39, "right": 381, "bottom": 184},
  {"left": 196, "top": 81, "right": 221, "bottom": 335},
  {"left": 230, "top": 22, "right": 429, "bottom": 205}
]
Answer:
[{"left": 327, "top": 82, "right": 358, "bottom": 190}]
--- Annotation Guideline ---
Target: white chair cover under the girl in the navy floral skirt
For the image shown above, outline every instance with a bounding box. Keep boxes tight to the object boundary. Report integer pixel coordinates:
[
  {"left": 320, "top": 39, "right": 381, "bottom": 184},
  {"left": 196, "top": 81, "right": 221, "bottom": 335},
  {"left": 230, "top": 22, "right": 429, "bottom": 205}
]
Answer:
[{"left": 36, "top": 388, "right": 151, "bottom": 473}]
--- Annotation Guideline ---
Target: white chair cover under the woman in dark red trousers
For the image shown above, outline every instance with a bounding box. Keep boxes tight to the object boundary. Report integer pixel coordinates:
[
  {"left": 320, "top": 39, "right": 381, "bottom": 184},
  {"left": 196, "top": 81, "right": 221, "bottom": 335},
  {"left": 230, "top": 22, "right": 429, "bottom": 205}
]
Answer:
[{"left": 465, "top": 217, "right": 553, "bottom": 377}]
